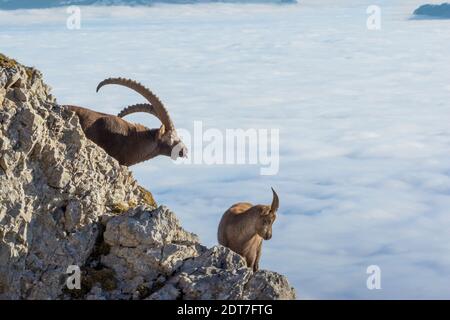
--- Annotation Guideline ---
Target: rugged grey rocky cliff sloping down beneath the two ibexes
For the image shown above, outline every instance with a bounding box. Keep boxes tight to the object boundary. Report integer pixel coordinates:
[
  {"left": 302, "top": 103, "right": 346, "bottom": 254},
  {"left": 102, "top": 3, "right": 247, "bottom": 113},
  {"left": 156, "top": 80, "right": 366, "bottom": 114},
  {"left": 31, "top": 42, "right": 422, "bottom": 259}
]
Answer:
[{"left": 0, "top": 54, "right": 295, "bottom": 299}]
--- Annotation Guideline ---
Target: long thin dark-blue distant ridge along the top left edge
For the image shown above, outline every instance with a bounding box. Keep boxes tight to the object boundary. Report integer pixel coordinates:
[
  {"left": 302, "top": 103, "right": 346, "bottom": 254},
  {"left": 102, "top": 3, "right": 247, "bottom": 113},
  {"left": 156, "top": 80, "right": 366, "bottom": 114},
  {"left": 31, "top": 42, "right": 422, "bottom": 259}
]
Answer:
[{"left": 0, "top": 0, "right": 297, "bottom": 10}]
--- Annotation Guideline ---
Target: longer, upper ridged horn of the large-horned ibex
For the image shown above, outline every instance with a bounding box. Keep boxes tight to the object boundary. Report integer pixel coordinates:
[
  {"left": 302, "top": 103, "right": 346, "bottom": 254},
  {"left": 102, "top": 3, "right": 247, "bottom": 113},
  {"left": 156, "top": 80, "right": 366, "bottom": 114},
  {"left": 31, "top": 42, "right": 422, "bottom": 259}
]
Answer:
[{"left": 97, "top": 78, "right": 174, "bottom": 130}]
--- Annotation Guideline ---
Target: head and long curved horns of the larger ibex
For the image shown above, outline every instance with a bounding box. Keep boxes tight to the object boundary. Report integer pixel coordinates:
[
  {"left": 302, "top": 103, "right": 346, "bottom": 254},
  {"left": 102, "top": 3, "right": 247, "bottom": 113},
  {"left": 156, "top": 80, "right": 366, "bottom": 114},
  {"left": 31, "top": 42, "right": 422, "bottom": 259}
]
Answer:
[{"left": 97, "top": 78, "right": 188, "bottom": 160}]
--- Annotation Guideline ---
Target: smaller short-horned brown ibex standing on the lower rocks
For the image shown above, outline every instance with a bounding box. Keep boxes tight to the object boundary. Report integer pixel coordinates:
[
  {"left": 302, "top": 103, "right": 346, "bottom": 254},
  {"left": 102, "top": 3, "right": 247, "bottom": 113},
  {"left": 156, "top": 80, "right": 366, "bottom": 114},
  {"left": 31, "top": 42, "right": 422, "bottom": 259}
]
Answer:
[{"left": 217, "top": 188, "right": 280, "bottom": 271}]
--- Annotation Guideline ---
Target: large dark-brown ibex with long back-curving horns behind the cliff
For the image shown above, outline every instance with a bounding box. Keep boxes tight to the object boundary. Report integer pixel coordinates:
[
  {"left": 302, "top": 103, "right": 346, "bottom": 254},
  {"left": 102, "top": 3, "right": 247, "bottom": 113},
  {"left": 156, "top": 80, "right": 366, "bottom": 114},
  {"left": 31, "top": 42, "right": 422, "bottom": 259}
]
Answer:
[{"left": 64, "top": 78, "right": 187, "bottom": 166}]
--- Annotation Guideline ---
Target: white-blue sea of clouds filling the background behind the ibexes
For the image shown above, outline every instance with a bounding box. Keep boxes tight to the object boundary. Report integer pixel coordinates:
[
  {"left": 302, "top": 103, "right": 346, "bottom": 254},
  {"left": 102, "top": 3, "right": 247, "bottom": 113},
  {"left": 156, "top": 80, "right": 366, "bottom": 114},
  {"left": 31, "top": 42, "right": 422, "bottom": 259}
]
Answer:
[{"left": 0, "top": 0, "right": 450, "bottom": 299}]
